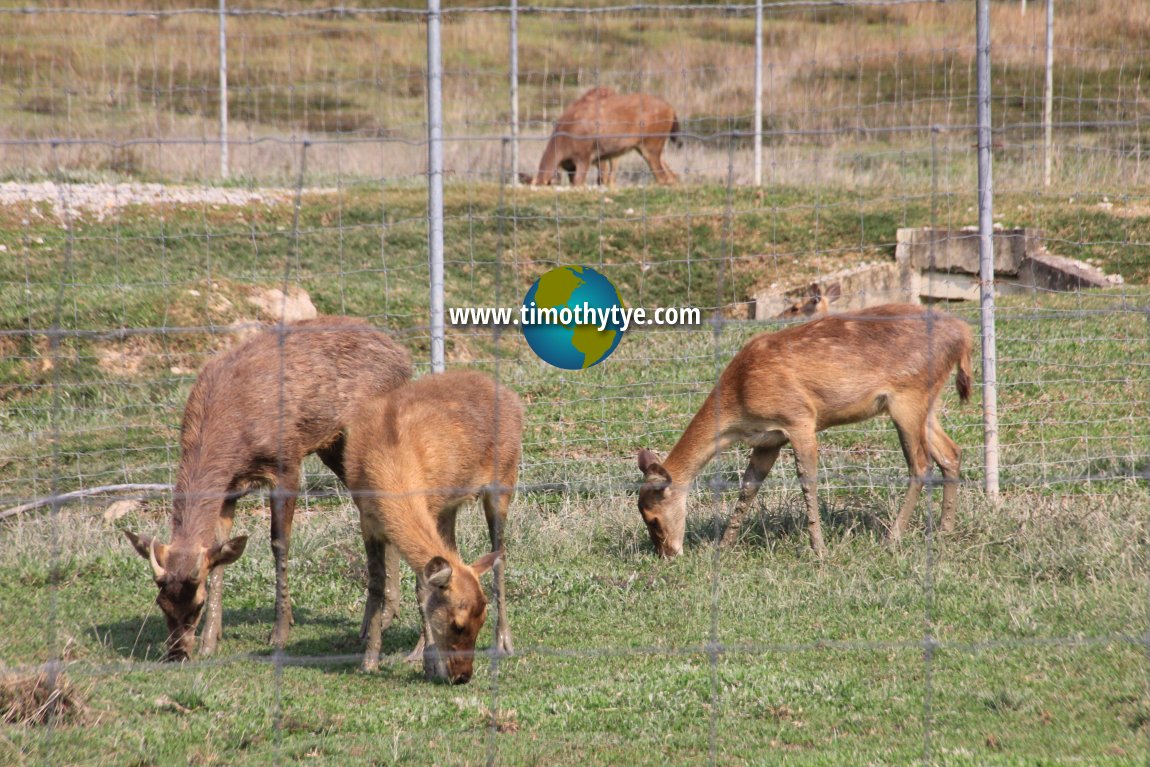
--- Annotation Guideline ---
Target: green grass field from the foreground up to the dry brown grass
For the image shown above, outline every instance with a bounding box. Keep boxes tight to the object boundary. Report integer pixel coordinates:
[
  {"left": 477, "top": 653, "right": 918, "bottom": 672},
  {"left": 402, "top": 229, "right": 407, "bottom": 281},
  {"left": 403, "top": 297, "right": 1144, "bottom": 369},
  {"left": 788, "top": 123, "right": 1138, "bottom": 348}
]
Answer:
[{"left": 0, "top": 178, "right": 1150, "bottom": 765}]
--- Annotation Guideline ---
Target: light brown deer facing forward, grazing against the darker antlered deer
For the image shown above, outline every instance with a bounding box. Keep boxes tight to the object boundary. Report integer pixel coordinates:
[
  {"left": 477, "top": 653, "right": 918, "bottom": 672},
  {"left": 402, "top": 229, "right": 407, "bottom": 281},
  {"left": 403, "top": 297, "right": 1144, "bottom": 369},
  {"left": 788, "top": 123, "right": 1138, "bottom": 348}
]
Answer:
[{"left": 344, "top": 370, "right": 523, "bottom": 684}]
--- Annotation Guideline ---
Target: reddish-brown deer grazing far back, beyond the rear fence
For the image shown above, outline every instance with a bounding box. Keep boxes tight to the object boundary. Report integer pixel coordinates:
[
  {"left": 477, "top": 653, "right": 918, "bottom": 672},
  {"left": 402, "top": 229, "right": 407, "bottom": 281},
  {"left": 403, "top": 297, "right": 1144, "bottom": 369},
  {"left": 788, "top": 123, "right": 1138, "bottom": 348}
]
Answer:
[{"left": 534, "top": 87, "right": 681, "bottom": 186}]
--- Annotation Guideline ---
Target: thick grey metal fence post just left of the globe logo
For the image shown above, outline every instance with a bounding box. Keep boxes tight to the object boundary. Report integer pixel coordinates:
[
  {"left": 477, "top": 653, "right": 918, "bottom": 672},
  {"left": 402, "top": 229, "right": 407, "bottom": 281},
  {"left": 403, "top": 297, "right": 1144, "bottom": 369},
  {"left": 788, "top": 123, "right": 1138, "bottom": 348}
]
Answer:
[{"left": 428, "top": 0, "right": 445, "bottom": 373}]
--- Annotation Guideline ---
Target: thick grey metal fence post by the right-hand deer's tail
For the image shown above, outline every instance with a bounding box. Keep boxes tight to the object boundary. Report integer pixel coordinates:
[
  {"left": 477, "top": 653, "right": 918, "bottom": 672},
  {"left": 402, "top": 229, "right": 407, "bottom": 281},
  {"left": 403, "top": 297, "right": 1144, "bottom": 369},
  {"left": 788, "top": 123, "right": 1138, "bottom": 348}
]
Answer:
[{"left": 976, "top": 0, "right": 998, "bottom": 501}]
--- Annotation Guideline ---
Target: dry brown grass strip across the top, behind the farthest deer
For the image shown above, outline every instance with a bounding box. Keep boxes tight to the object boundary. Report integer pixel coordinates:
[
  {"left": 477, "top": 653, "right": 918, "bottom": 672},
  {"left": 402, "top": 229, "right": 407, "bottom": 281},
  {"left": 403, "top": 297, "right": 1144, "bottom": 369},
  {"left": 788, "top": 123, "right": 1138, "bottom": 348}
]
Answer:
[{"left": 0, "top": 0, "right": 1150, "bottom": 183}]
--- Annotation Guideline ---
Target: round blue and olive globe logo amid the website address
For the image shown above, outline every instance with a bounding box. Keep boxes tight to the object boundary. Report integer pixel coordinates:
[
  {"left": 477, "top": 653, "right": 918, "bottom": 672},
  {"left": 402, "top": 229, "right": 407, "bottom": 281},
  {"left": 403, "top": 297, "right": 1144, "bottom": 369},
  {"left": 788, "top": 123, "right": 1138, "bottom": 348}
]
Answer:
[{"left": 520, "top": 267, "right": 623, "bottom": 370}]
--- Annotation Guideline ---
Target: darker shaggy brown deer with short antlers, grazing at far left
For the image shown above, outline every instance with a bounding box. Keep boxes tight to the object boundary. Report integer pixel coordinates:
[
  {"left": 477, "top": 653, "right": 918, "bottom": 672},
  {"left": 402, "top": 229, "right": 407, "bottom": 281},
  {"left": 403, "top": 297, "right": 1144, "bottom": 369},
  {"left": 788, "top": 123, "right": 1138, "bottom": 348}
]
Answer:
[{"left": 124, "top": 317, "right": 412, "bottom": 660}]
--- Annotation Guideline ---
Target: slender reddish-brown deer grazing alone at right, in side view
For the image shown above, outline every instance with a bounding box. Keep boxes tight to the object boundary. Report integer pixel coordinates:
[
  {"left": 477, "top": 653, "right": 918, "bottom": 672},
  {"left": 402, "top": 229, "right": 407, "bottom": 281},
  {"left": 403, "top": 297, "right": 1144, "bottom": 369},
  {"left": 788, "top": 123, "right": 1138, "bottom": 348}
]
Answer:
[{"left": 638, "top": 304, "right": 971, "bottom": 557}]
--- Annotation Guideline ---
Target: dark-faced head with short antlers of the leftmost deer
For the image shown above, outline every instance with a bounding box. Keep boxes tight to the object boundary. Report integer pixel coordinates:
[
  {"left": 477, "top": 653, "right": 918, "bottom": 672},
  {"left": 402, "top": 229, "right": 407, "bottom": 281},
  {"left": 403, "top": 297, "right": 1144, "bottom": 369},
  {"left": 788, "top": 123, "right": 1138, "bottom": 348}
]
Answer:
[{"left": 124, "top": 530, "right": 247, "bottom": 661}]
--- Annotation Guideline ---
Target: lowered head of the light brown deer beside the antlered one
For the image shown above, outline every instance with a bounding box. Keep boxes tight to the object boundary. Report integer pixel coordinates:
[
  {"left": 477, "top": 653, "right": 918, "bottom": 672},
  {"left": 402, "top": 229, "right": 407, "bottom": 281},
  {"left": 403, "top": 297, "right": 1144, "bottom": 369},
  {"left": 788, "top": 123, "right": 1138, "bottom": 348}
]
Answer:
[{"left": 420, "top": 552, "right": 500, "bottom": 684}]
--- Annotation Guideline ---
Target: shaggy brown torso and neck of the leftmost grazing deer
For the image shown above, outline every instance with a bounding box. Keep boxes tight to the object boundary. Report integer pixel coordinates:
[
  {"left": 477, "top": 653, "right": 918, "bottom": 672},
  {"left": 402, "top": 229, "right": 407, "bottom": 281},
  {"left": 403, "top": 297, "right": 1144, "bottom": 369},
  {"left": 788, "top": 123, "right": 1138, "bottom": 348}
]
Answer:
[{"left": 173, "top": 316, "right": 412, "bottom": 542}]
